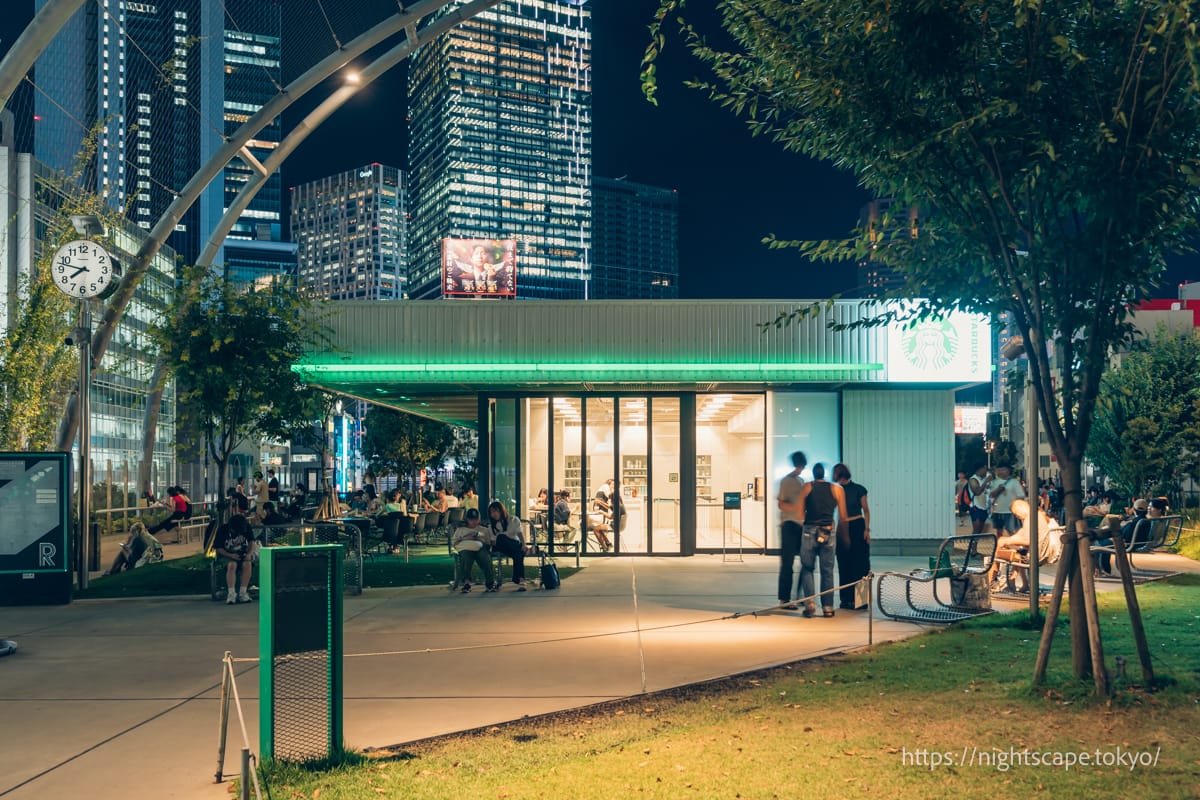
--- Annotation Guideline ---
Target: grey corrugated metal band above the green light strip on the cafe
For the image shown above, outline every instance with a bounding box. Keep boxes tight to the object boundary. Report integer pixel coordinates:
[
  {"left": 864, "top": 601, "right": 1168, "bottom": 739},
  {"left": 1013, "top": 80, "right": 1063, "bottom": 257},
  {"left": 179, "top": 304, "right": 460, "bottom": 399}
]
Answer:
[{"left": 313, "top": 300, "right": 887, "bottom": 383}]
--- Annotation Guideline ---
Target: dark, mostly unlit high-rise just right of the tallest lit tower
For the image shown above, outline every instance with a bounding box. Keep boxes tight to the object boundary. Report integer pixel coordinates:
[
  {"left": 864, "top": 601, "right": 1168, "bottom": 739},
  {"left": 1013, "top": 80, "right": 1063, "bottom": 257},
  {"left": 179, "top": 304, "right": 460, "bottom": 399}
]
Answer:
[{"left": 588, "top": 178, "right": 679, "bottom": 300}]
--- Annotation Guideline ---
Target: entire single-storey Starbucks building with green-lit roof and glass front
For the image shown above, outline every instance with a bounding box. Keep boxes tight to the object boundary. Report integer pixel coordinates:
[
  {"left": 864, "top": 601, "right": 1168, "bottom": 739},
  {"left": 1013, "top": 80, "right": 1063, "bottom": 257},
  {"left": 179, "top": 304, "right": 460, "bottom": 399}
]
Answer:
[{"left": 301, "top": 301, "right": 990, "bottom": 555}]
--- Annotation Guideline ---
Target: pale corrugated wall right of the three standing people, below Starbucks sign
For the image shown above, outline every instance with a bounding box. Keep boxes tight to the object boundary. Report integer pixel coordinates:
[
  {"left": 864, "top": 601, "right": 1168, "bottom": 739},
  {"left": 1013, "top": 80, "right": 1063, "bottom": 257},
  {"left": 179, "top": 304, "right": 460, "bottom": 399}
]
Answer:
[{"left": 841, "top": 390, "right": 954, "bottom": 539}]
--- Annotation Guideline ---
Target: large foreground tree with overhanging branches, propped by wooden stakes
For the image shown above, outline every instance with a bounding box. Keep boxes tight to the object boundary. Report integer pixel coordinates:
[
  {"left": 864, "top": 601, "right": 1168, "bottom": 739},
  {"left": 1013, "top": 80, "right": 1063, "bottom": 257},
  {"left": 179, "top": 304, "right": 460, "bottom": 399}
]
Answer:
[{"left": 643, "top": 0, "right": 1200, "bottom": 691}]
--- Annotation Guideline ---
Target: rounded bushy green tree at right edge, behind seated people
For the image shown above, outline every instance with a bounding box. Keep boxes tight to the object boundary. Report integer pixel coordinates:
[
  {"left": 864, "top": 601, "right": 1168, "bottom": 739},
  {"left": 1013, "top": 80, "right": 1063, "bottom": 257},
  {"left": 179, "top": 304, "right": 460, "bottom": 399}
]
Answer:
[{"left": 1087, "top": 327, "right": 1200, "bottom": 498}]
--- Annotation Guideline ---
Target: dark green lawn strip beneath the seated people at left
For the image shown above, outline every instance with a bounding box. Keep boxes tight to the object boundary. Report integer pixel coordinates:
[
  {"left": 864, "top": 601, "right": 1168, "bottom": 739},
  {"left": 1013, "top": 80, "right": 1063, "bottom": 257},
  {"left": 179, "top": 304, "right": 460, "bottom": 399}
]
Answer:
[{"left": 74, "top": 547, "right": 578, "bottom": 600}]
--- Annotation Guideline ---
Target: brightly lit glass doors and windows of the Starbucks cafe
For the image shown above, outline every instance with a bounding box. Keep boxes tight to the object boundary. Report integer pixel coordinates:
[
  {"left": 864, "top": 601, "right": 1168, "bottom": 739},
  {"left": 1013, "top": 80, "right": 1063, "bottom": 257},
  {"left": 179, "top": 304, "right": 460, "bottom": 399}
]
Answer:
[{"left": 481, "top": 393, "right": 778, "bottom": 555}]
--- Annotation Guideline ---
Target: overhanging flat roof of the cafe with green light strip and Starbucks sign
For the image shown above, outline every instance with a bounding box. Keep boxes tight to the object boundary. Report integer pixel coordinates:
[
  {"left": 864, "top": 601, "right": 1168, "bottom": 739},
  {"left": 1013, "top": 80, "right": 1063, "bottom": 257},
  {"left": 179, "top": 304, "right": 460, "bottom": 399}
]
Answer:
[{"left": 295, "top": 300, "right": 991, "bottom": 427}]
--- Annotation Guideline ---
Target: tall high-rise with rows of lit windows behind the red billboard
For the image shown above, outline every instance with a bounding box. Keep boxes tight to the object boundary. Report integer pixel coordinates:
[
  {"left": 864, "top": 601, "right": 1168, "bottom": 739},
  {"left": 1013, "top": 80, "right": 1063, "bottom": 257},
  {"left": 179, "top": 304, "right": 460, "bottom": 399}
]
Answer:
[{"left": 408, "top": 0, "right": 592, "bottom": 299}]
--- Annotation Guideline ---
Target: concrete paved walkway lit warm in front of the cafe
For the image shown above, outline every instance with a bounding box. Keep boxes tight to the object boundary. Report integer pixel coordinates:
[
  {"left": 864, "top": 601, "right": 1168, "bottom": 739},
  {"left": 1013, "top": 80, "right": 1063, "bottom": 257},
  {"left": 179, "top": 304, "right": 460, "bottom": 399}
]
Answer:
[{"left": 0, "top": 557, "right": 1194, "bottom": 800}]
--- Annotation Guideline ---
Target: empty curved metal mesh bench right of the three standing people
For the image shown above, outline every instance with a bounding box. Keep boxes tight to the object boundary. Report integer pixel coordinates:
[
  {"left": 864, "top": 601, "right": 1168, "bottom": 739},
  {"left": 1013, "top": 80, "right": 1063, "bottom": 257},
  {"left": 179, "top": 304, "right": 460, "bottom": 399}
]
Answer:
[{"left": 875, "top": 534, "right": 996, "bottom": 624}]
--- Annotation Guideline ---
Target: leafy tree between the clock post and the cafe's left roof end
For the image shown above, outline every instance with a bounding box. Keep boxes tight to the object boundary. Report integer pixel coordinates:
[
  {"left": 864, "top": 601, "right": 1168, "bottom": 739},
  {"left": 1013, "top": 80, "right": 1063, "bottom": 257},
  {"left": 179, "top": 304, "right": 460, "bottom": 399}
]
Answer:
[{"left": 154, "top": 268, "right": 323, "bottom": 506}]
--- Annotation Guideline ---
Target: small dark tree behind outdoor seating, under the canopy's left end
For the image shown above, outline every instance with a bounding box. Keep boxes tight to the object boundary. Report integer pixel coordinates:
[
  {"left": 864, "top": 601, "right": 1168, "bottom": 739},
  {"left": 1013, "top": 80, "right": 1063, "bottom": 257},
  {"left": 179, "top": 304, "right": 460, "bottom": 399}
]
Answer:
[{"left": 362, "top": 405, "right": 454, "bottom": 486}]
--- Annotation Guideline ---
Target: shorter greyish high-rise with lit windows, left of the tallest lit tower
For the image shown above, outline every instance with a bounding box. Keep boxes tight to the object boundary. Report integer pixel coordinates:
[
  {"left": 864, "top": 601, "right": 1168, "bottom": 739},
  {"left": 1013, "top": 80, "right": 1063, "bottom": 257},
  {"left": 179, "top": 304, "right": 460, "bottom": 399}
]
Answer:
[{"left": 292, "top": 164, "right": 406, "bottom": 300}]
